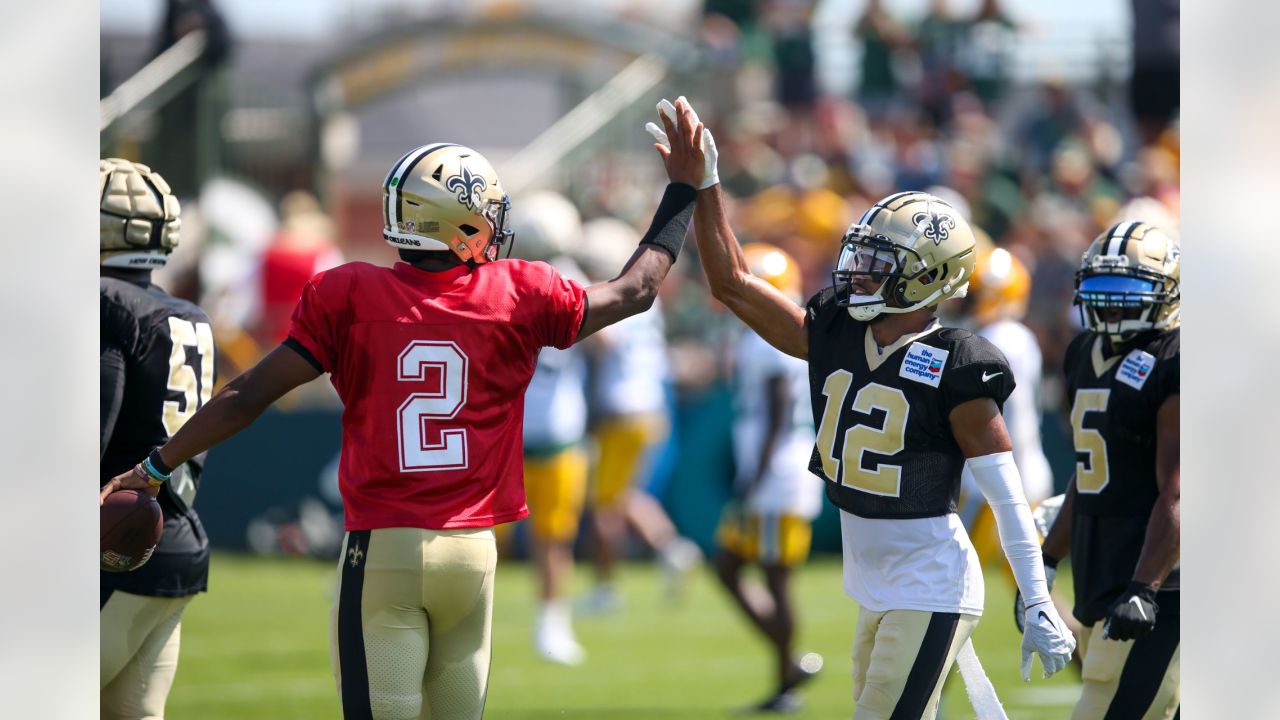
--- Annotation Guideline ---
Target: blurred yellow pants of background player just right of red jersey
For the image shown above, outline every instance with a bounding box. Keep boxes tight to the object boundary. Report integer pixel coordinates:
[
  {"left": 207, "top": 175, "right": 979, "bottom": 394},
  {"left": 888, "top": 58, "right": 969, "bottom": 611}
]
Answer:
[{"left": 525, "top": 447, "right": 586, "bottom": 542}]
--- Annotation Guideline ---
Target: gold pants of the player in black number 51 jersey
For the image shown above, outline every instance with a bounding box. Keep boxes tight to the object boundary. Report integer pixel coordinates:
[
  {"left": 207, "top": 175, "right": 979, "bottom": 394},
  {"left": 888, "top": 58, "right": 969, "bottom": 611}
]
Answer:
[{"left": 99, "top": 591, "right": 195, "bottom": 720}]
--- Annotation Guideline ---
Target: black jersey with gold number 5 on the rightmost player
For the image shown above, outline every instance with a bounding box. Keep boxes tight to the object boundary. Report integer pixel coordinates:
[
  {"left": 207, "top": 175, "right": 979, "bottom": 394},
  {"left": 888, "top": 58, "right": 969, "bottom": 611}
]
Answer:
[{"left": 1062, "top": 329, "right": 1181, "bottom": 624}]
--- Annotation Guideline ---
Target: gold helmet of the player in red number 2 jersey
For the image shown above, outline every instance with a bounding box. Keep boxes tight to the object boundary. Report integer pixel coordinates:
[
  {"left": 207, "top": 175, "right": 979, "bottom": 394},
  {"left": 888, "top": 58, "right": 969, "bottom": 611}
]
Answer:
[{"left": 383, "top": 142, "right": 512, "bottom": 263}]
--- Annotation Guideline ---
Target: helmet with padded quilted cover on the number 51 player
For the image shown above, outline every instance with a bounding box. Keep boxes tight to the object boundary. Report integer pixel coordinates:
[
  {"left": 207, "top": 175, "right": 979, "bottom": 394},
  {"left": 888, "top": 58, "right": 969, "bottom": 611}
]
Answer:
[{"left": 97, "top": 158, "right": 182, "bottom": 269}]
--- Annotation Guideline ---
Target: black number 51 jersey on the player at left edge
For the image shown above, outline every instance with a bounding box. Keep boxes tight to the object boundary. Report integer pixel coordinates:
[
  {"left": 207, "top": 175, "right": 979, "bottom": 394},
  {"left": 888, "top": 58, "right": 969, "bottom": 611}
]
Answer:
[{"left": 99, "top": 278, "right": 214, "bottom": 597}]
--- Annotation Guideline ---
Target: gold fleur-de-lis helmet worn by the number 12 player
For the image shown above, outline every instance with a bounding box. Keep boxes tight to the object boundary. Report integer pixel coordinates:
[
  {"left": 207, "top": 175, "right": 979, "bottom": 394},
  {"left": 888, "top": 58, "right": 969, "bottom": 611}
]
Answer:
[{"left": 831, "top": 192, "right": 974, "bottom": 322}]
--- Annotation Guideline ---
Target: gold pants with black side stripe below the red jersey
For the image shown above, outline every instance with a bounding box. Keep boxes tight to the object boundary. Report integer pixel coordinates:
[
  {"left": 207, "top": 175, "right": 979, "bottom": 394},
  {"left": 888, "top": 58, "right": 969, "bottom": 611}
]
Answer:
[{"left": 329, "top": 520, "right": 498, "bottom": 720}]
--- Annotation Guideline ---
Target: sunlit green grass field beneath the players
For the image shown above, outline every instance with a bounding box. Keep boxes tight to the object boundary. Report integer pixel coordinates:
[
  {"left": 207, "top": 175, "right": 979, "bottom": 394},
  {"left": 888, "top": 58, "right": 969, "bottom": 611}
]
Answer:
[{"left": 168, "top": 555, "right": 1078, "bottom": 720}]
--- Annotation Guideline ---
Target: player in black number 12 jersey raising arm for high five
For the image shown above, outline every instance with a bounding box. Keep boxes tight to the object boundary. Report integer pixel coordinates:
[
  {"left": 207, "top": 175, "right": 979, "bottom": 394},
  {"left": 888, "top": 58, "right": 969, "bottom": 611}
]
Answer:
[{"left": 649, "top": 101, "right": 1075, "bottom": 720}]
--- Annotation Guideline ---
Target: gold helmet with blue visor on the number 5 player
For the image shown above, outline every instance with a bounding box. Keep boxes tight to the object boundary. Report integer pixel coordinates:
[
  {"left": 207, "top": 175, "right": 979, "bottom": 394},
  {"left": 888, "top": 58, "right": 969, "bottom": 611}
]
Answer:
[{"left": 1074, "top": 220, "right": 1181, "bottom": 341}]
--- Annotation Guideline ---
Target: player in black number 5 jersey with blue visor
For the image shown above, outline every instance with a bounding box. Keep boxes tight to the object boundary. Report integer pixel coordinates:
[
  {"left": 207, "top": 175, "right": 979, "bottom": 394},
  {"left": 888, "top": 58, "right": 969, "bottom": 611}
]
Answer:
[{"left": 1044, "top": 222, "right": 1181, "bottom": 720}]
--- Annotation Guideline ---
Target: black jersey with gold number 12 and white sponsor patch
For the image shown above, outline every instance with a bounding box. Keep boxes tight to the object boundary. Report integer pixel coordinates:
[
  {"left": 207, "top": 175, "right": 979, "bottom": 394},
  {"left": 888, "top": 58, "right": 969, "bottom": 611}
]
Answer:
[{"left": 805, "top": 288, "right": 1014, "bottom": 518}]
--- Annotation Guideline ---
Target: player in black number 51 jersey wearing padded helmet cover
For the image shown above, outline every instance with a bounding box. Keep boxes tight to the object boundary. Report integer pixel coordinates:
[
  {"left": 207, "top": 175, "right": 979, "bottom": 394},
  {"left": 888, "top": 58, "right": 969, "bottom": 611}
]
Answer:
[{"left": 99, "top": 159, "right": 214, "bottom": 720}]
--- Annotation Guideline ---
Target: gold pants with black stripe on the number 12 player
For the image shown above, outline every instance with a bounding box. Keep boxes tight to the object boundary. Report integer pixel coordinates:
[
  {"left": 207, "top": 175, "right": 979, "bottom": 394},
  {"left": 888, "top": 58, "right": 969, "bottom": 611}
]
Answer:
[{"left": 854, "top": 609, "right": 978, "bottom": 720}]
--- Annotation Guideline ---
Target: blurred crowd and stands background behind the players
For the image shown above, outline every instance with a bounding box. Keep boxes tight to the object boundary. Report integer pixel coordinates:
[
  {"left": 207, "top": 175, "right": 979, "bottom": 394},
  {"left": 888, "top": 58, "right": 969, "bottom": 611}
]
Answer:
[{"left": 101, "top": 0, "right": 1179, "bottom": 553}]
